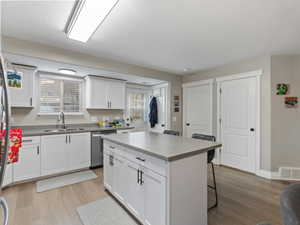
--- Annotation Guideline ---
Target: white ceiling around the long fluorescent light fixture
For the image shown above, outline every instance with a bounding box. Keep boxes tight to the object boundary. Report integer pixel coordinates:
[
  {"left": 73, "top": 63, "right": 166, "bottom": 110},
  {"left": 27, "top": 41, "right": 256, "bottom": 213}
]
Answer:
[{"left": 2, "top": 0, "right": 300, "bottom": 74}]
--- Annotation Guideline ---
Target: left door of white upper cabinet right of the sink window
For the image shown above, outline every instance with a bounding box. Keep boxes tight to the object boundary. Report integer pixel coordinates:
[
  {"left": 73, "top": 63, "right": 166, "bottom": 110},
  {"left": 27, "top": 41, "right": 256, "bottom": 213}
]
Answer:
[{"left": 86, "top": 77, "right": 108, "bottom": 109}]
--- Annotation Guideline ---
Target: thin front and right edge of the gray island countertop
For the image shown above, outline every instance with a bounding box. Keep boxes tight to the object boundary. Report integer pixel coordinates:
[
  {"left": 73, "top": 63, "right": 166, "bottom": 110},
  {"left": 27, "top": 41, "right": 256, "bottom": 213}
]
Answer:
[{"left": 103, "top": 136, "right": 222, "bottom": 162}]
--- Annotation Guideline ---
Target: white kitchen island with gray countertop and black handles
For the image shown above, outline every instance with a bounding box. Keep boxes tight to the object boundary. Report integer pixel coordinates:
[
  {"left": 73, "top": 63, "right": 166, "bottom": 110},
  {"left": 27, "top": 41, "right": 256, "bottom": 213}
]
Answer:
[{"left": 104, "top": 132, "right": 221, "bottom": 225}]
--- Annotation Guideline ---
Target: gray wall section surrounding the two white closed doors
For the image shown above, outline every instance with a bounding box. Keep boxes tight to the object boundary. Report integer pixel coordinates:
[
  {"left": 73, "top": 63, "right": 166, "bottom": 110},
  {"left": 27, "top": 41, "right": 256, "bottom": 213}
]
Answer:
[{"left": 183, "top": 56, "right": 271, "bottom": 170}]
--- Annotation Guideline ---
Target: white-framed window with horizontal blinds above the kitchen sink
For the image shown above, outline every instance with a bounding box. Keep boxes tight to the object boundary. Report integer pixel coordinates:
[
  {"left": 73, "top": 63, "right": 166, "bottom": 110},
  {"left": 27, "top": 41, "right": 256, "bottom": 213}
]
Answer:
[{"left": 39, "top": 75, "right": 83, "bottom": 114}]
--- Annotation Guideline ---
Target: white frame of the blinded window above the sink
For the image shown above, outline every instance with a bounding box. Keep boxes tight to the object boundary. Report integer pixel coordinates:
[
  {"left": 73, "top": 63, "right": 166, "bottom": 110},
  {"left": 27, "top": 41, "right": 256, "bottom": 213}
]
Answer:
[{"left": 37, "top": 71, "right": 85, "bottom": 116}]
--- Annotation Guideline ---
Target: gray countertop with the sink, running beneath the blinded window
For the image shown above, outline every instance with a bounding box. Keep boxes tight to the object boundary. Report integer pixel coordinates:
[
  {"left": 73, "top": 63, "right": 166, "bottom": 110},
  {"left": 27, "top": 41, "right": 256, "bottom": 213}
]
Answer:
[{"left": 12, "top": 124, "right": 134, "bottom": 137}]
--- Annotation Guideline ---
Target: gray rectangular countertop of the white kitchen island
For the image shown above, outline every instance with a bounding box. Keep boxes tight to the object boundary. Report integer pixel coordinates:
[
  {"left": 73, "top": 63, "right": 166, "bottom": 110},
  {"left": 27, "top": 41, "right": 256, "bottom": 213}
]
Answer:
[{"left": 103, "top": 132, "right": 222, "bottom": 161}]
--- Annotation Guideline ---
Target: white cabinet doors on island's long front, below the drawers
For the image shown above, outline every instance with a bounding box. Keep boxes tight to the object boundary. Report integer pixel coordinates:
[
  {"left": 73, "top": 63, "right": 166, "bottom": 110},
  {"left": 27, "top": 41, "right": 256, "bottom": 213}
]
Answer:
[{"left": 104, "top": 143, "right": 167, "bottom": 225}]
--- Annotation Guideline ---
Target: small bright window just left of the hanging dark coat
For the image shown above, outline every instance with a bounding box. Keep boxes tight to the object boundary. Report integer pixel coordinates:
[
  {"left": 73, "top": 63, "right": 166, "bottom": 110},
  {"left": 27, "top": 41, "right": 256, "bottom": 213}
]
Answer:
[{"left": 127, "top": 89, "right": 148, "bottom": 122}]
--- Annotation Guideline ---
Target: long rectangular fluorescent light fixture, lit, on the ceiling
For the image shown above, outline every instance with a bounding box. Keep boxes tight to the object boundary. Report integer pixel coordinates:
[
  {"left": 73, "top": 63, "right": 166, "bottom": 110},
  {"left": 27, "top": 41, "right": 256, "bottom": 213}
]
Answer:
[{"left": 67, "top": 0, "right": 119, "bottom": 42}]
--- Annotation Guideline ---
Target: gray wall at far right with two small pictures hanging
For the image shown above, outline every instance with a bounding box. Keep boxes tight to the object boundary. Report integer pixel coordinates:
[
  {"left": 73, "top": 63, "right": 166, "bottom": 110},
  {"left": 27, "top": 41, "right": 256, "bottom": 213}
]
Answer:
[{"left": 271, "top": 56, "right": 300, "bottom": 171}]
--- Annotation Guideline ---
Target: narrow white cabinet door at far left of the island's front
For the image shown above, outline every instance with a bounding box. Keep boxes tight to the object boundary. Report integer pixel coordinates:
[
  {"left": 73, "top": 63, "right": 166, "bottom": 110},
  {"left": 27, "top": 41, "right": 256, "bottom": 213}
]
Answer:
[{"left": 103, "top": 151, "right": 114, "bottom": 192}]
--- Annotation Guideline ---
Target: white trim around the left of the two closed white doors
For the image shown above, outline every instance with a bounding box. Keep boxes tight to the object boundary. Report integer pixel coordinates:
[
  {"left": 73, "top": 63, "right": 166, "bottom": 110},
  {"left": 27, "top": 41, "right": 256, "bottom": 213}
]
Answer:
[{"left": 182, "top": 79, "right": 214, "bottom": 136}]
